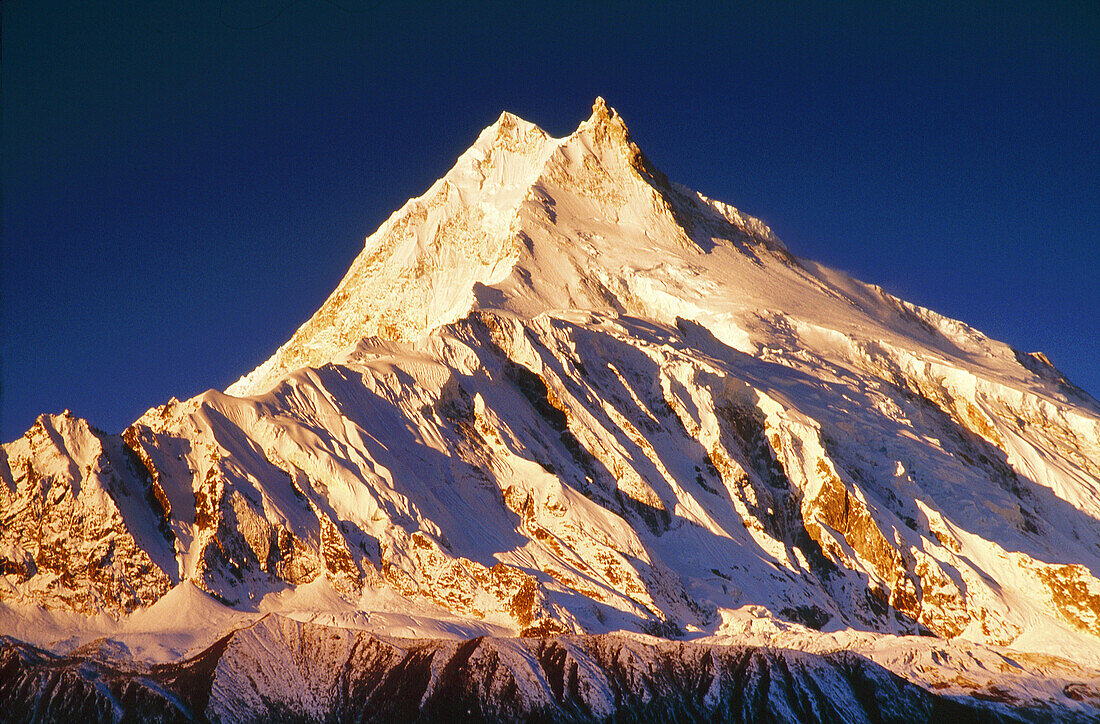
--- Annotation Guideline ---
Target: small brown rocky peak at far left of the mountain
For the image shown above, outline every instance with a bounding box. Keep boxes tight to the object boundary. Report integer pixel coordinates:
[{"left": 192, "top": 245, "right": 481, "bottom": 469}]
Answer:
[{"left": 0, "top": 414, "right": 171, "bottom": 614}]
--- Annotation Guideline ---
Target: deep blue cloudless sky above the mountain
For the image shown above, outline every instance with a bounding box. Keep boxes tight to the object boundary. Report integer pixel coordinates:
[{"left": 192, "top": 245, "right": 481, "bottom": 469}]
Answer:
[{"left": 0, "top": 0, "right": 1100, "bottom": 440}]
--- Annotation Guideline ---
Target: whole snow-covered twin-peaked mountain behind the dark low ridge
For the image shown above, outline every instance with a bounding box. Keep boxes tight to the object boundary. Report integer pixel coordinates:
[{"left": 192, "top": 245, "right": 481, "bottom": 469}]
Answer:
[{"left": 0, "top": 99, "right": 1100, "bottom": 721}]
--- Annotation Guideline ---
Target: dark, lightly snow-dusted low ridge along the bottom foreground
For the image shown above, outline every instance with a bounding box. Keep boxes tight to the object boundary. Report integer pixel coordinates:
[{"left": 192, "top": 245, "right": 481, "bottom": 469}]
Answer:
[{"left": 0, "top": 616, "right": 1086, "bottom": 724}]
